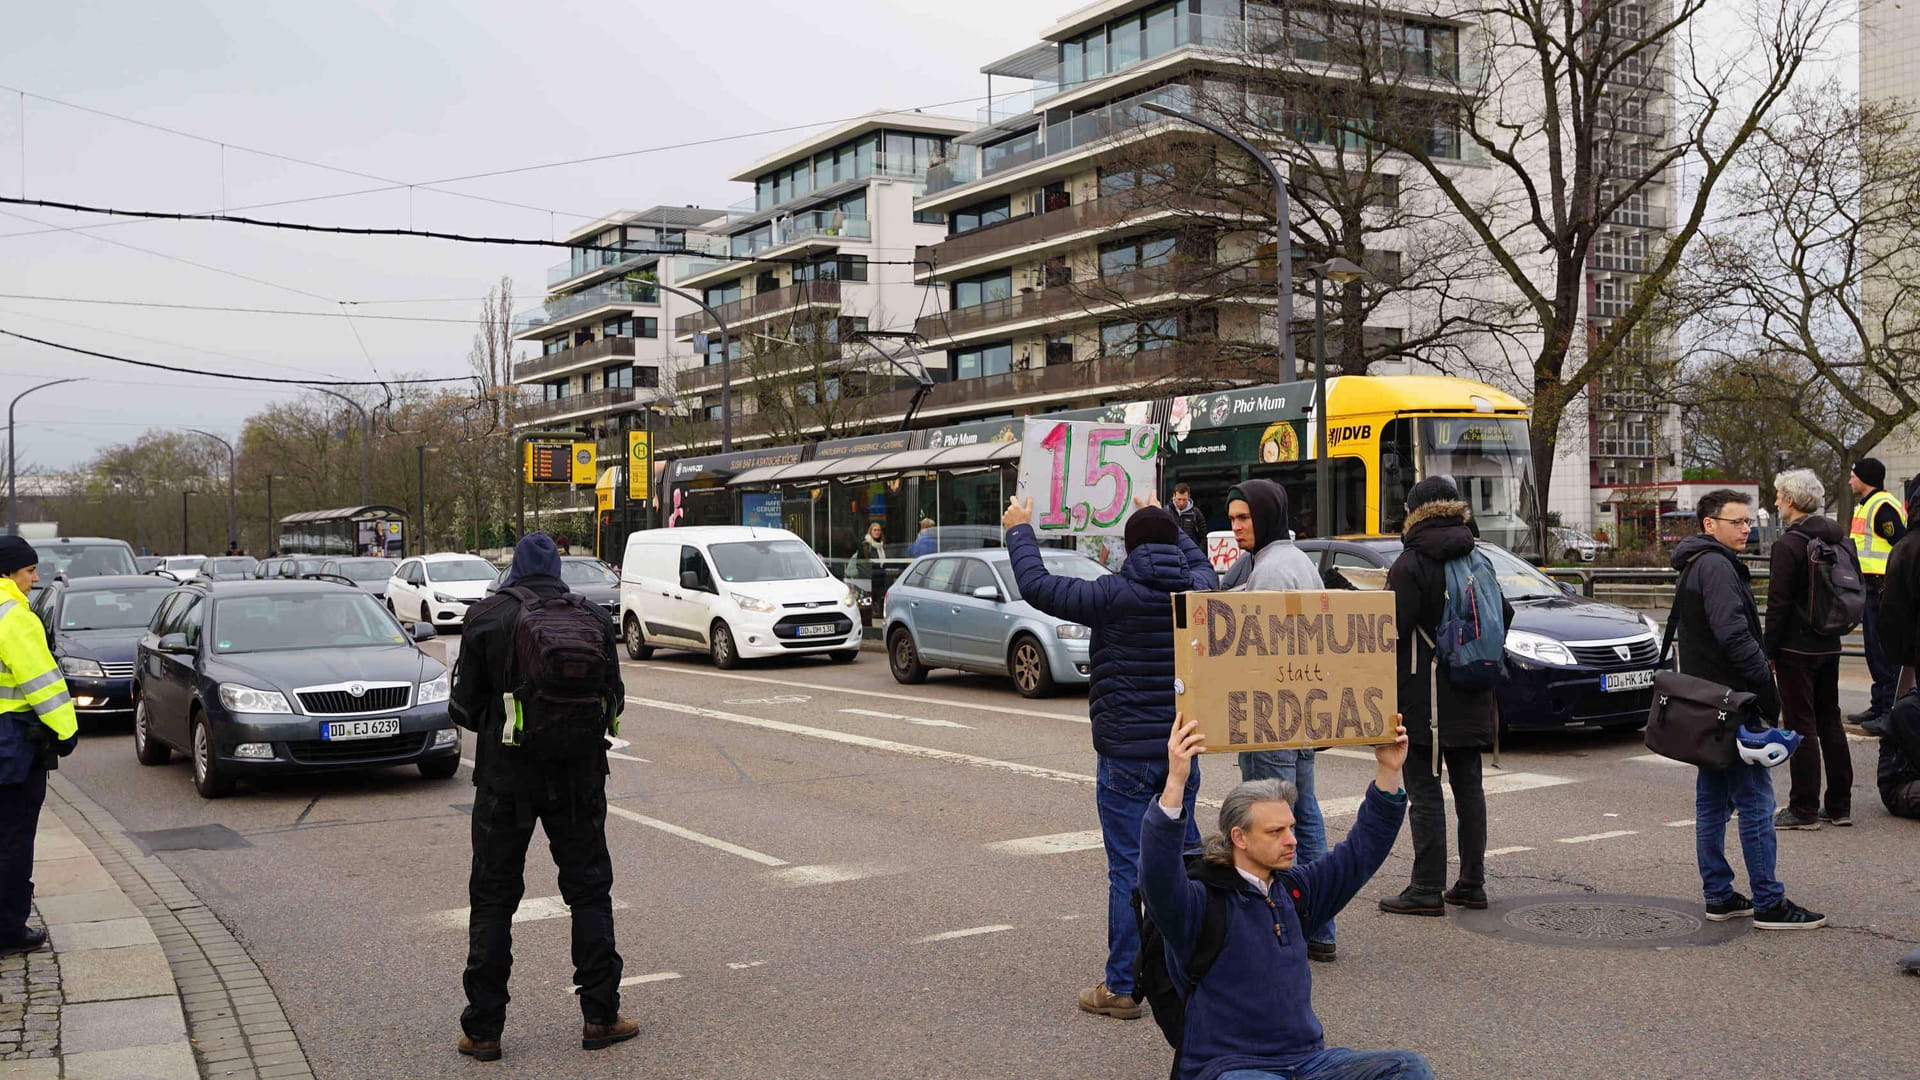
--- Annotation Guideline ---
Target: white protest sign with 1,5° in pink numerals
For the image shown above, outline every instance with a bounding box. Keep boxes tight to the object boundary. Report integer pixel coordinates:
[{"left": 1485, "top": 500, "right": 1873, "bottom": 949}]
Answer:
[{"left": 1016, "top": 417, "right": 1160, "bottom": 538}]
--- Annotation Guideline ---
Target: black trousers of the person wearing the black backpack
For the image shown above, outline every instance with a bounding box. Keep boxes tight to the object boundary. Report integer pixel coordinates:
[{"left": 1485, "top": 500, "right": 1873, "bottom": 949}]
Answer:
[{"left": 461, "top": 776, "right": 622, "bottom": 1040}]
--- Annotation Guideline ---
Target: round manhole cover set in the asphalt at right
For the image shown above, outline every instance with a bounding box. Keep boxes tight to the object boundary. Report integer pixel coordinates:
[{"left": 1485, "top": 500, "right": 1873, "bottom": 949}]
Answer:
[{"left": 1453, "top": 894, "right": 1751, "bottom": 949}]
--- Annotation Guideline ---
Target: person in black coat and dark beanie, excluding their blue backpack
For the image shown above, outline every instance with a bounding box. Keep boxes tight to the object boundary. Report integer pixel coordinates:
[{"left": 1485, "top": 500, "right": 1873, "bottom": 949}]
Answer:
[{"left": 1380, "top": 477, "right": 1513, "bottom": 915}]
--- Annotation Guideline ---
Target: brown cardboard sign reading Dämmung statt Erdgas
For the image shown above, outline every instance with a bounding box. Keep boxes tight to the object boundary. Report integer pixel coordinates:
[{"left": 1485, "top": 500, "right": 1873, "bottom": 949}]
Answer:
[{"left": 1173, "top": 590, "right": 1400, "bottom": 753}]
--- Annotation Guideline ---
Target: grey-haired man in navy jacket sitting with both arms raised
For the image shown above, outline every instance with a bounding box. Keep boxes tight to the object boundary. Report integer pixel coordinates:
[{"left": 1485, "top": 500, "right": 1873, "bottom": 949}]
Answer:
[{"left": 1140, "top": 715, "right": 1432, "bottom": 1080}]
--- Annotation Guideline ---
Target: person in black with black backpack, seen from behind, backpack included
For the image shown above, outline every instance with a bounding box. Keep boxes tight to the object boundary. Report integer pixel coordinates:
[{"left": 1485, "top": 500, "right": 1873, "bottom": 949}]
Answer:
[{"left": 449, "top": 532, "right": 639, "bottom": 1061}]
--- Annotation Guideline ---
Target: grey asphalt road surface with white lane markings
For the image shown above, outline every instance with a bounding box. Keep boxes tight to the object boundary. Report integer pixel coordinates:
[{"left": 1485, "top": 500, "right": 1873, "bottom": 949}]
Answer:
[{"left": 52, "top": 653, "right": 1920, "bottom": 1080}]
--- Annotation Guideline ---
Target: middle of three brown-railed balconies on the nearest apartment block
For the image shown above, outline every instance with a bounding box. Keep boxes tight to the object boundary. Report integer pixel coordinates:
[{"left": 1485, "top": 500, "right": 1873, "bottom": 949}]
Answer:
[{"left": 914, "top": 261, "right": 1275, "bottom": 342}]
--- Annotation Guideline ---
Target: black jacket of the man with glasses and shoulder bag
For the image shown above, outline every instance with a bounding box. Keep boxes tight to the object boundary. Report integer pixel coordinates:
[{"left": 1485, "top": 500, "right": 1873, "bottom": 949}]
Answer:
[{"left": 1672, "top": 532, "right": 1780, "bottom": 724}]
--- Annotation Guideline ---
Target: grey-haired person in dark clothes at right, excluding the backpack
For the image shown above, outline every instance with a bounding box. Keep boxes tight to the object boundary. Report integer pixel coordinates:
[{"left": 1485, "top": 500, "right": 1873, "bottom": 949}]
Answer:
[{"left": 1761, "top": 469, "right": 1859, "bottom": 828}]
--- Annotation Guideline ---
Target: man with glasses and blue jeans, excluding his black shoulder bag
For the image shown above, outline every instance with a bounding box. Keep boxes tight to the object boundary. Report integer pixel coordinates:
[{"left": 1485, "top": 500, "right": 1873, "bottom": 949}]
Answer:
[{"left": 1672, "top": 488, "right": 1826, "bottom": 930}]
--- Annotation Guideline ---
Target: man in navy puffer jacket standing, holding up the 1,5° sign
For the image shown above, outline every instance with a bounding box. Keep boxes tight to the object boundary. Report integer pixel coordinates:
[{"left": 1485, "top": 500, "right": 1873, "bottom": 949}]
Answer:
[{"left": 1000, "top": 498, "right": 1219, "bottom": 1020}]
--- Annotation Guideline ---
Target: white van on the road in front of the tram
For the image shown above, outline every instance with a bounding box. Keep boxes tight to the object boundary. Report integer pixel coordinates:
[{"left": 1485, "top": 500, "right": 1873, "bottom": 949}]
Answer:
[{"left": 620, "top": 525, "right": 860, "bottom": 667}]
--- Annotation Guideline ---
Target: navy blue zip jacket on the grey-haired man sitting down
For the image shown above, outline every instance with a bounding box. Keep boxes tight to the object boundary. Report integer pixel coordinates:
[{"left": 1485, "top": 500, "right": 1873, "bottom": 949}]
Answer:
[{"left": 1140, "top": 784, "right": 1407, "bottom": 1080}]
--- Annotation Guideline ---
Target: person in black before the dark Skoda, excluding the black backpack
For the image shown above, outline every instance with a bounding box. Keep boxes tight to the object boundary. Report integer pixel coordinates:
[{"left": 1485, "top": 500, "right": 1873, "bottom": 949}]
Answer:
[{"left": 447, "top": 532, "right": 639, "bottom": 1061}]
